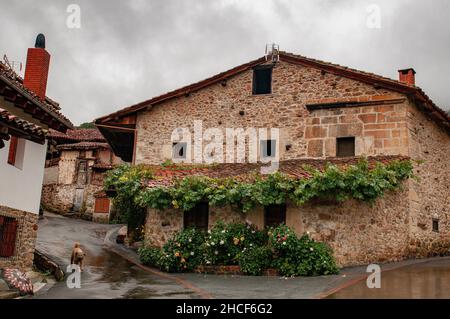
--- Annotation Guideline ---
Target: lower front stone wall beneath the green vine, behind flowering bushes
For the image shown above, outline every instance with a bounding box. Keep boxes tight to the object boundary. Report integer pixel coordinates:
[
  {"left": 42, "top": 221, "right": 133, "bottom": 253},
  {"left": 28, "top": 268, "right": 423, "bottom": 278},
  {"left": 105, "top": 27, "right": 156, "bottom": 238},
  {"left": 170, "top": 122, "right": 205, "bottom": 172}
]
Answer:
[{"left": 145, "top": 188, "right": 409, "bottom": 266}]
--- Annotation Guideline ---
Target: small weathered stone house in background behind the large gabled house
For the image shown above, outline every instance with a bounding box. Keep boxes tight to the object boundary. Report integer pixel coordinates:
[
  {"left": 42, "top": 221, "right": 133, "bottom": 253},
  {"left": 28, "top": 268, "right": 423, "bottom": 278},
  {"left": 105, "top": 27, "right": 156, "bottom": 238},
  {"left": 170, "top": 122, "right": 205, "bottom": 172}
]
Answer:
[{"left": 42, "top": 128, "right": 122, "bottom": 222}]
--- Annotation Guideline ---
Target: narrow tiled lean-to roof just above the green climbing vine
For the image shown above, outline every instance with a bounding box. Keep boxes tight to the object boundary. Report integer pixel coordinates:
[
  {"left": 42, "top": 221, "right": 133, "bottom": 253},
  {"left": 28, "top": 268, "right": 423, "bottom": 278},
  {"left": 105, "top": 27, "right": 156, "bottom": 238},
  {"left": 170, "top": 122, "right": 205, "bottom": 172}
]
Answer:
[{"left": 146, "top": 156, "right": 409, "bottom": 187}]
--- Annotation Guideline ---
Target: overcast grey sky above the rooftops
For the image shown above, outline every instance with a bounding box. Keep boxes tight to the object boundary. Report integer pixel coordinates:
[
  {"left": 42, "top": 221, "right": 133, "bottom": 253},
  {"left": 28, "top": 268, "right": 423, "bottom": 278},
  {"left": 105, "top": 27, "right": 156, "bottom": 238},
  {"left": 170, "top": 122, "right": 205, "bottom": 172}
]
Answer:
[{"left": 0, "top": 0, "right": 450, "bottom": 124}]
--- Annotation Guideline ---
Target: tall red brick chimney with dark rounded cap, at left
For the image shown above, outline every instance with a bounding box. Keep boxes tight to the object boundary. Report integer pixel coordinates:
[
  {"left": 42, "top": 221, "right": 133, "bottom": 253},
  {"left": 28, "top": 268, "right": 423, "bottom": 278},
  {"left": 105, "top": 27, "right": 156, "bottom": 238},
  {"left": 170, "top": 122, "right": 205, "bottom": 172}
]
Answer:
[{"left": 23, "top": 33, "right": 50, "bottom": 100}]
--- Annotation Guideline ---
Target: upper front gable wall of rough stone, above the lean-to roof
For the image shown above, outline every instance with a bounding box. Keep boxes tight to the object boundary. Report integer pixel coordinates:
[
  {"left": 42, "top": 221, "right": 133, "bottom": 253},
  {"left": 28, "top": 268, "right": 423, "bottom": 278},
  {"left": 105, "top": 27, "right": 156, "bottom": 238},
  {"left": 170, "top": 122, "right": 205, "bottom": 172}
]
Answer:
[{"left": 135, "top": 62, "right": 405, "bottom": 164}]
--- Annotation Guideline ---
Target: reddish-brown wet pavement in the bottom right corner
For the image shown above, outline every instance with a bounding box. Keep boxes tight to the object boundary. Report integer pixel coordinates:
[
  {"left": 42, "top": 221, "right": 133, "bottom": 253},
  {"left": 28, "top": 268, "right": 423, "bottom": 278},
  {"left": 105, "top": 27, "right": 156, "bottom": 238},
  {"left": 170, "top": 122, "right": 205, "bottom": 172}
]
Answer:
[{"left": 328, "top": 258, "right": 450, "bottom": 299}]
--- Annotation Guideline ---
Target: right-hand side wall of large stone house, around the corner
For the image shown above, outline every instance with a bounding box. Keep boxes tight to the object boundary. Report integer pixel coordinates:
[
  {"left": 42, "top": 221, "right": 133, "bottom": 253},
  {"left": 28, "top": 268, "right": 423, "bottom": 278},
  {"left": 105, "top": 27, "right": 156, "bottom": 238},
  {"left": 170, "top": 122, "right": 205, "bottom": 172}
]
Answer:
[{"left": 408, "top": 101, "right": 450, "bottom": 257}]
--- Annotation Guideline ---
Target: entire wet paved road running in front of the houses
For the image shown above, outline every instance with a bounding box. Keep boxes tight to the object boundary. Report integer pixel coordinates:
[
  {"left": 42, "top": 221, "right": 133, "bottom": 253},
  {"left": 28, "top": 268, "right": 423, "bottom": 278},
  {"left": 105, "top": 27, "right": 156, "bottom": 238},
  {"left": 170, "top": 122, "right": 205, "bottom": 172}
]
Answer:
[{"left": 36, "top": 215, "right": 450, "bottom": 299}]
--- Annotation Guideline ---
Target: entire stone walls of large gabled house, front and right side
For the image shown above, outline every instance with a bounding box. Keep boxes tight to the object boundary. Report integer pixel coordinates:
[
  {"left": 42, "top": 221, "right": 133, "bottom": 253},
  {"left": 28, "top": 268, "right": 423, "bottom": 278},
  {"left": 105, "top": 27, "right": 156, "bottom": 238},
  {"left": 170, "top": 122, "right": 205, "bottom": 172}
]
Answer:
[{"left": 135, "top": 61, "right": 450, "bottom": 265}]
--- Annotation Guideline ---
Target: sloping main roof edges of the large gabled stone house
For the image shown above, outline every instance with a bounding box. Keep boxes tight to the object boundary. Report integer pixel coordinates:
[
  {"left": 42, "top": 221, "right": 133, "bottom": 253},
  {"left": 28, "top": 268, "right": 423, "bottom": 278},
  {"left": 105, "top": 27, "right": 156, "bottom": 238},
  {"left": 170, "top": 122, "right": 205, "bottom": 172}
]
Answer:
[{"left": 95, "top": 51, "right": 450, "bottom": 132}]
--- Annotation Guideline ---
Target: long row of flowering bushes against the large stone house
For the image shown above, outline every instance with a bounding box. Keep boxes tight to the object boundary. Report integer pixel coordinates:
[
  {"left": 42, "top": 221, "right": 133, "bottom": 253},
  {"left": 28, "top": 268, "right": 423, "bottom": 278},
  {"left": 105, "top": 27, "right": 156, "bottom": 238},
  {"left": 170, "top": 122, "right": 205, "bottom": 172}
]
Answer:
[{"left": 139, "top": 222, "right": 338, "bottom": 276}]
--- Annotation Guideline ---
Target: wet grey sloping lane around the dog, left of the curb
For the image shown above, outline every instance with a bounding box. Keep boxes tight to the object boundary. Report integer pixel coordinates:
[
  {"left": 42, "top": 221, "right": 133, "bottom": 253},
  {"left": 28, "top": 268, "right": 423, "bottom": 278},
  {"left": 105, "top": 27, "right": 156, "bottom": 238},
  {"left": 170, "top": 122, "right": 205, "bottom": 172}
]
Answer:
[{"left": 35, "top": 217, "right": 196, "bottom": 298}]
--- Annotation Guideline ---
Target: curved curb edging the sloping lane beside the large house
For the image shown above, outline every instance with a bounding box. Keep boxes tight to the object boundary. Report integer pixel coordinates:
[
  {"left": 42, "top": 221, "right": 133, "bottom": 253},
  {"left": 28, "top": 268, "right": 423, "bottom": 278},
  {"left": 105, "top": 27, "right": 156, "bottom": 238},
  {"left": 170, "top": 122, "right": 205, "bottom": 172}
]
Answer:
[{"left": 104, "top": 228, "right": 213, "bottom": 299}]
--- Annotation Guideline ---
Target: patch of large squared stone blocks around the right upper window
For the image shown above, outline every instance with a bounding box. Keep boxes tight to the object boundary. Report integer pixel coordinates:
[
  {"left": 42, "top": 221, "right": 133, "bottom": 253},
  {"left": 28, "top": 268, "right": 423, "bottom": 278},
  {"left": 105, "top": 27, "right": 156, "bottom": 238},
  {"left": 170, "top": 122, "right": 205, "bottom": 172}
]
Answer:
[{"left": 304, "top": 95, "right": 408, "bottom": 158}]
